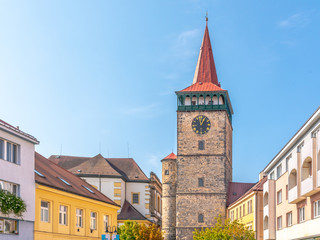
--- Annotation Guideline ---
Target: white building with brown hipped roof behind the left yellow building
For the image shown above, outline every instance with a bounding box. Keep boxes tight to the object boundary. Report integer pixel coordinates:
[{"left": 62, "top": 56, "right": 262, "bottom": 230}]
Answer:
[{"left": 49, "top": 154, "right": 162, "bottom": 225}]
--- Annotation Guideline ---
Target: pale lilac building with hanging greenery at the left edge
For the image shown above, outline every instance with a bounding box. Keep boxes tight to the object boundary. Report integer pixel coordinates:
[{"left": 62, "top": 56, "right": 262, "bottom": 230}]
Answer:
[{"left": 0, "top": 120, "right": 39, "bottom": 240}]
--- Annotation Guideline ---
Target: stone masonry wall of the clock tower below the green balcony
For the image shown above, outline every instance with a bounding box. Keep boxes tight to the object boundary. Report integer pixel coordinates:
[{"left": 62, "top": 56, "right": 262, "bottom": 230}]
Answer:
[{"left": 176, "top": 111, "right": 232, "bottom": 240}]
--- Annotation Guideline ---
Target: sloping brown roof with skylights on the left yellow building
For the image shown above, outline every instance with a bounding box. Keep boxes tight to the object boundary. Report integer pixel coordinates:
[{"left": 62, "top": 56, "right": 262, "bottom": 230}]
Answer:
[{"left": 35, "top": 153, "right": 120, "bottom": 207}]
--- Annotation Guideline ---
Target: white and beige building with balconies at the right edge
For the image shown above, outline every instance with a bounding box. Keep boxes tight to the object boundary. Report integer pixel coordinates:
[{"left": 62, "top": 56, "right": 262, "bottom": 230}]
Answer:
[{"left": 261, "top": 108, "right": 320, "bottom": 240}]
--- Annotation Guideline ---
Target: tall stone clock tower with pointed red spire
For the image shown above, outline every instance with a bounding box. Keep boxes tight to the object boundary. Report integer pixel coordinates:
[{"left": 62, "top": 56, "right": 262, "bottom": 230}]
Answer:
[{"left": 172, "top": 19, "right": 233, "bottom": 240}]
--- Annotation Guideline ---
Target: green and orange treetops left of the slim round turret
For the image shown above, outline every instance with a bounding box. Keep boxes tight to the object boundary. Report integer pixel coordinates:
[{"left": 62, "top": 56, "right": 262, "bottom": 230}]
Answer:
[{"left": 118, "top": 221, "right": 163, "bottom": 240}]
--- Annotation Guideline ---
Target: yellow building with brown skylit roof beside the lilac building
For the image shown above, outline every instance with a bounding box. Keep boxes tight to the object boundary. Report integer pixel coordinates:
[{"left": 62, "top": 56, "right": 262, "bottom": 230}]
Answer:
[{"left": 34, "top": 153, "right": 120, "bottom": 240}]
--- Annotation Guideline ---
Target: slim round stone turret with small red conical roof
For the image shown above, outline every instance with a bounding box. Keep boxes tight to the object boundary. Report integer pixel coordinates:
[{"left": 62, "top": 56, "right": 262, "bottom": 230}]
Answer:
[{"left": 161, "top": 153, "right": 177, "bottom": 240}]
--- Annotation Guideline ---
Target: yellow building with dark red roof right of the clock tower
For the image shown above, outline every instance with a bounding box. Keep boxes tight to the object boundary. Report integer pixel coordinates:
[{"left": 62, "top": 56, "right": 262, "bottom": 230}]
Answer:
[{"left": 227, "top": 177, "right": 267, "bottom": 240}]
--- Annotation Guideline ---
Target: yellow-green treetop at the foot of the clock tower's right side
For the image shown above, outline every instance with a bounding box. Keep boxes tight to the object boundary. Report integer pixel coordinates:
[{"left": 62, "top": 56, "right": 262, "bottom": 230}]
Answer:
[{"left": 193, "top": 216, "right": 255, "bottom": 240}]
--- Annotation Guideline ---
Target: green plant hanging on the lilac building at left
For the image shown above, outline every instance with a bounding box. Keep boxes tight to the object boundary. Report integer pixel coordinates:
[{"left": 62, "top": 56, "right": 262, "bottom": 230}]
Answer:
[{"left": 0, "top": 190, "right": 27, "bottom": 217}]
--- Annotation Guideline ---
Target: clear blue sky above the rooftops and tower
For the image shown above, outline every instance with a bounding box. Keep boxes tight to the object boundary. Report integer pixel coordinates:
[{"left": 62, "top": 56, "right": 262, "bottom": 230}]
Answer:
[{"left": 0, "top": 0, "right": 320, "bottom": 182}]
